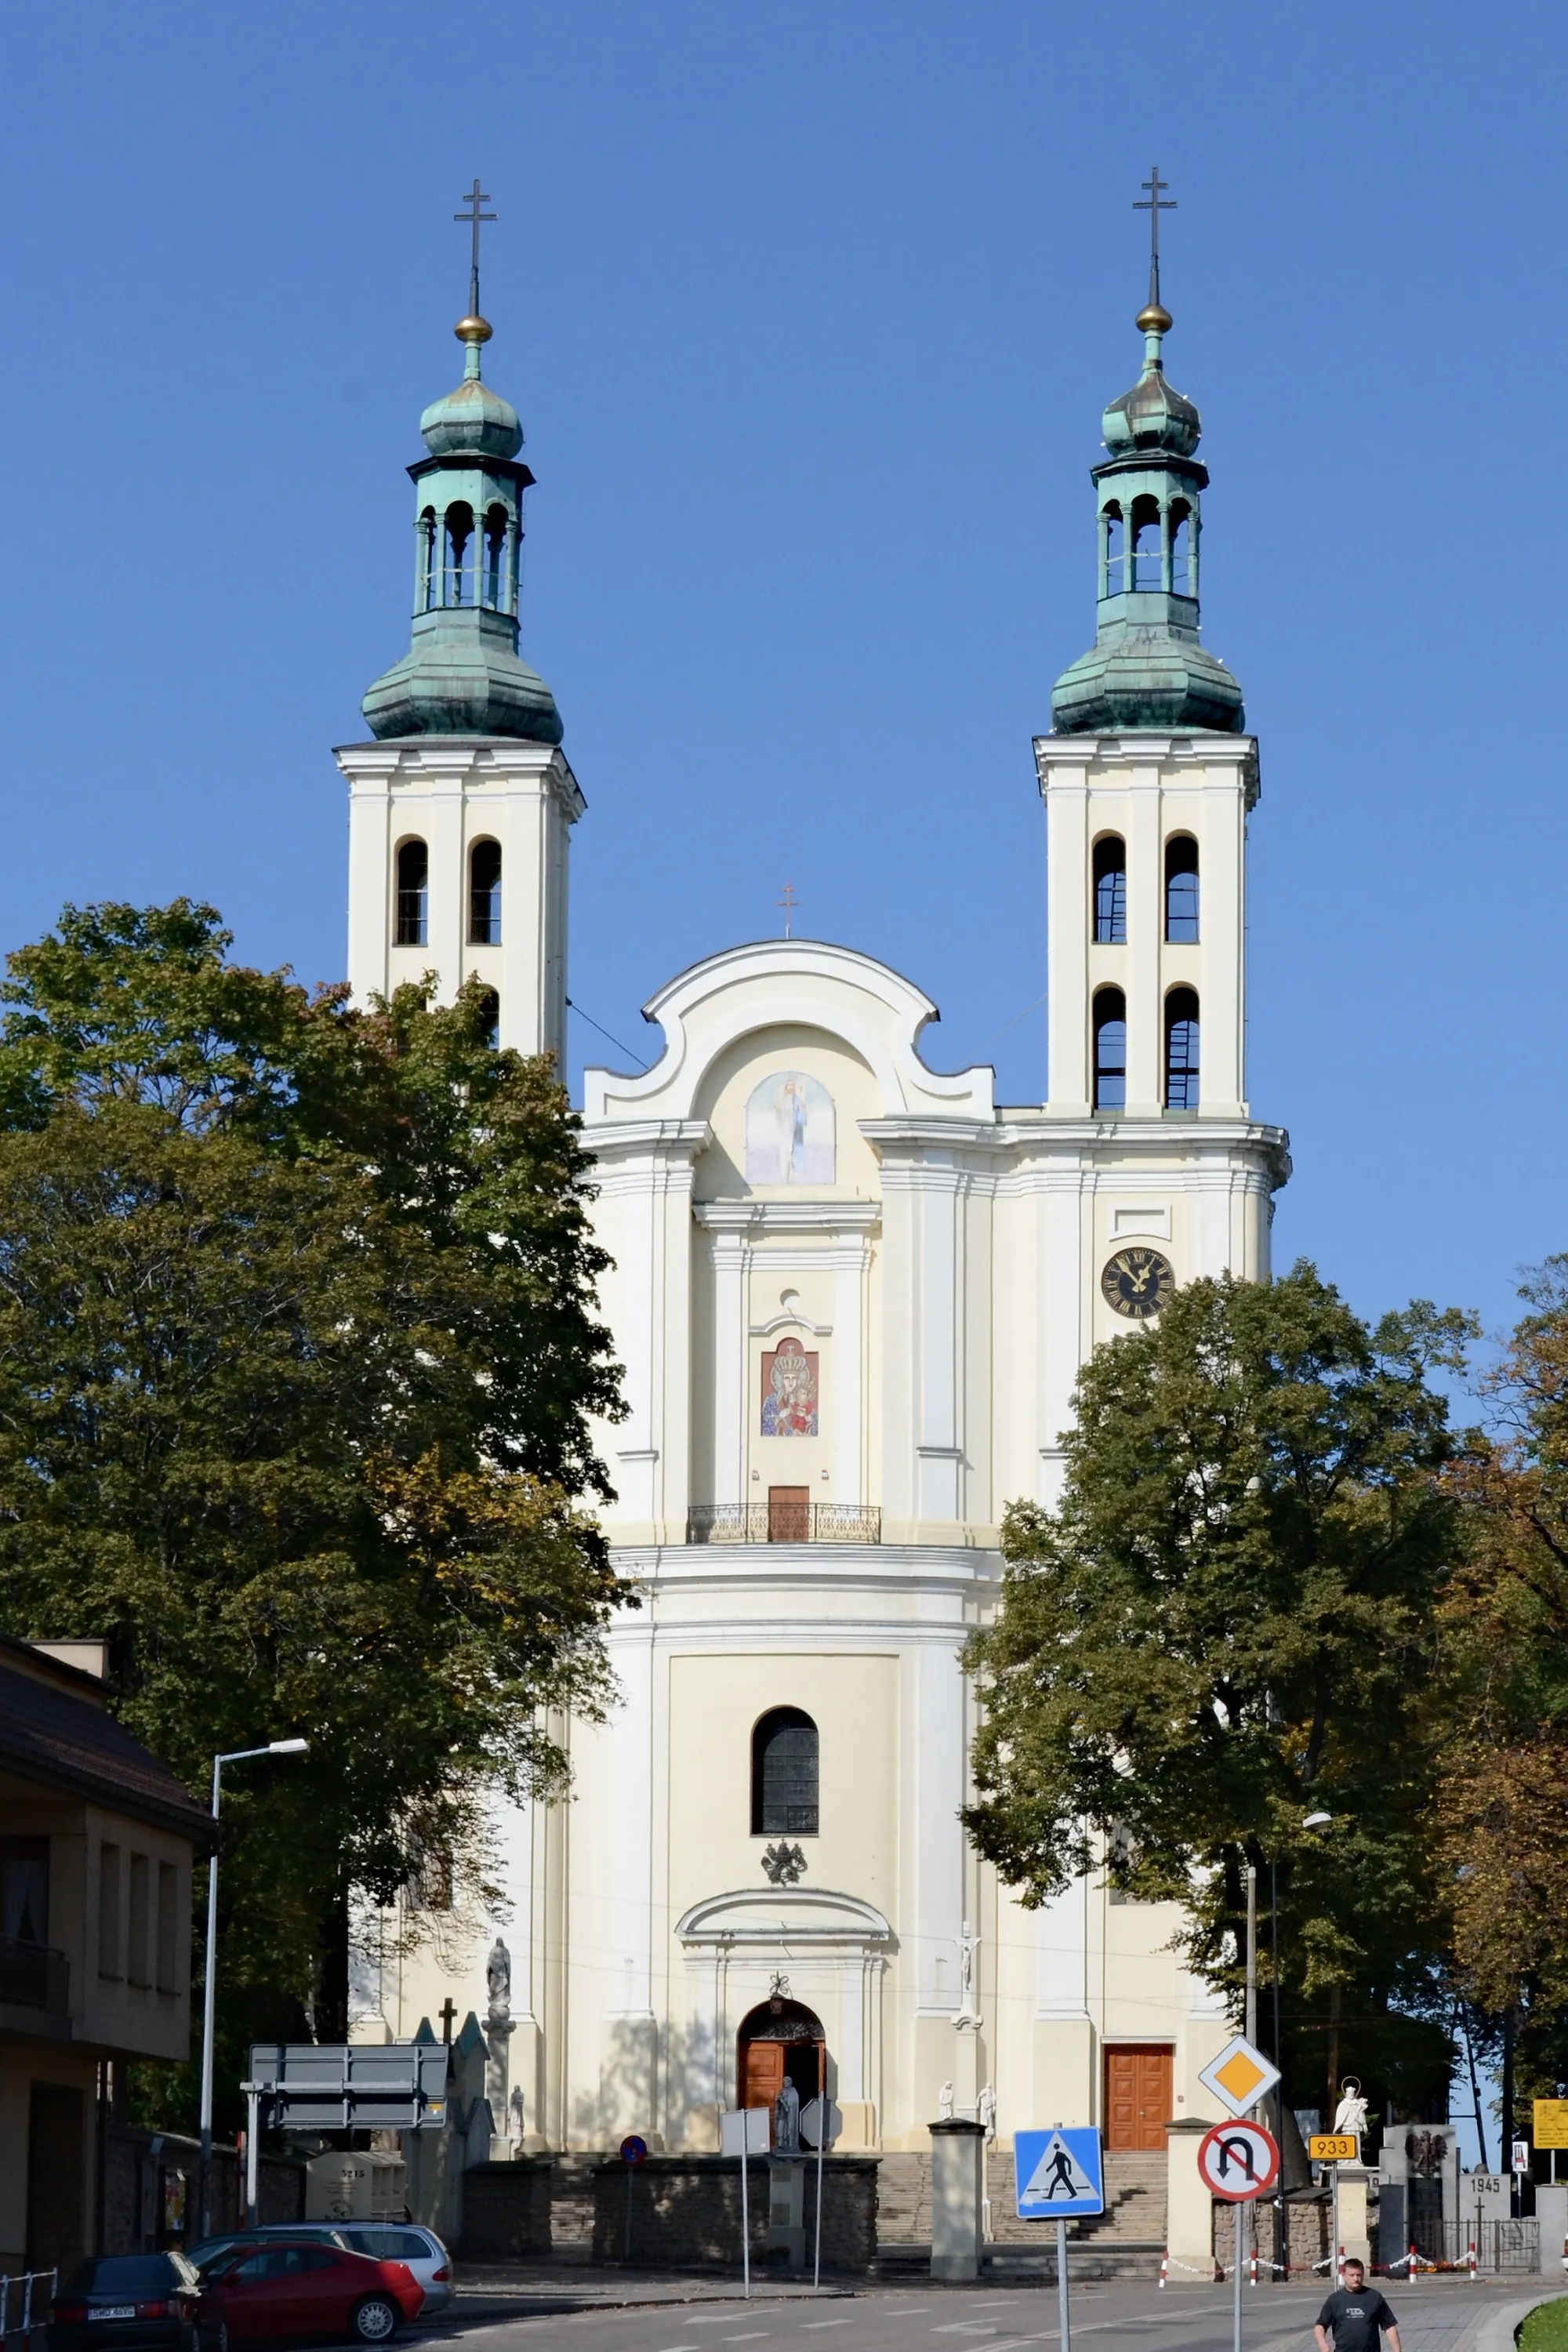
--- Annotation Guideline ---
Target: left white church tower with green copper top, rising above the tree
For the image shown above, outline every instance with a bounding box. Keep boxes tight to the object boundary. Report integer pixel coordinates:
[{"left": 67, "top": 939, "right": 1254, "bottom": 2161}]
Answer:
[{"left": 336, "top": 212, "right": 583, "bottom": 1058}]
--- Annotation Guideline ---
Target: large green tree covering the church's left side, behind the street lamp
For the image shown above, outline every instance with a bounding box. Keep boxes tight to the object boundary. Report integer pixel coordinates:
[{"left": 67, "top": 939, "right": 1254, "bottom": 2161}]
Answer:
[{"left": 0, "top": 901, "right": 623, "bottom": 2117}]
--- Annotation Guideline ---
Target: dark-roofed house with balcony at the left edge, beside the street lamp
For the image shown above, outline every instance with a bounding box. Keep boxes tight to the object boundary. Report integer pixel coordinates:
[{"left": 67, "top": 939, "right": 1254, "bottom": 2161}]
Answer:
[{"left": 0, "top": 1637, "right": 212, "bottom": 2272}]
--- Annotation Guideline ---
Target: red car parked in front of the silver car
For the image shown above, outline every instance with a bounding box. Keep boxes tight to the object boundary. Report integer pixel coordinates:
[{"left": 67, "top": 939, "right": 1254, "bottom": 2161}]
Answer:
[{"left": 200, "top": 2237, "right": 426, "bottom": 2352}]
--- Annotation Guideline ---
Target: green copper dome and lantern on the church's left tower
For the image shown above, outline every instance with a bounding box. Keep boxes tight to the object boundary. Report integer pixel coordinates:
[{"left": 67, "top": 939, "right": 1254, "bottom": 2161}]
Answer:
[{"left": 362, "top": 301, "right": 562, "bottom": 743}]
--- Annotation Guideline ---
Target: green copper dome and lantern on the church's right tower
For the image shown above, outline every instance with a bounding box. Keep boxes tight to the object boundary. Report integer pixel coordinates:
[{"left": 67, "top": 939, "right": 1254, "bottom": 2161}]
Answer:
[{"left": 1051, "top": 290, "right": 1246, "bottom": 734}]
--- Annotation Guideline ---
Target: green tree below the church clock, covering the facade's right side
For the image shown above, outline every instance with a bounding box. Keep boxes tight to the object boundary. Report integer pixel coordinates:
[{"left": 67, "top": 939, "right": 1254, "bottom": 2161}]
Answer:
[{"left": 966, "top": 1263, "right": 1469, "bottom": 2105}]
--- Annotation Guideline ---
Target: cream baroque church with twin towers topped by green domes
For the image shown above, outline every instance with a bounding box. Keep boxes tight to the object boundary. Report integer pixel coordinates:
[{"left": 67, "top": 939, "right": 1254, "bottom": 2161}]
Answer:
[{"left": 336, "top": 221, "right": 1290, "bottom": 2152}]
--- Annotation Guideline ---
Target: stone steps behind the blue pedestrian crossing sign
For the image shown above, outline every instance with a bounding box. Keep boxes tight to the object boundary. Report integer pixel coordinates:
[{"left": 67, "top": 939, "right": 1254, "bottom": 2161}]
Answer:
[{"left": 874, "top": 2140, "right": 1166, "bottom": 2279}]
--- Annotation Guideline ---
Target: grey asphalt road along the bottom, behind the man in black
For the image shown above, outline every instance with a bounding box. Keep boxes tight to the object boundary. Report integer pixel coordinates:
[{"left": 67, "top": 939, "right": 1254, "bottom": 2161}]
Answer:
[{"left": 423, "top": 2279, "right": 1552, "bottom": 2352}]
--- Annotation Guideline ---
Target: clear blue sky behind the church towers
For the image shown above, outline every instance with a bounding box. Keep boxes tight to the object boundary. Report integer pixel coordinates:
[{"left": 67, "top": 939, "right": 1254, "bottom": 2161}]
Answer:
[{"left": 0, "top": 0, "right": 1568, "bottom": 1364}]
